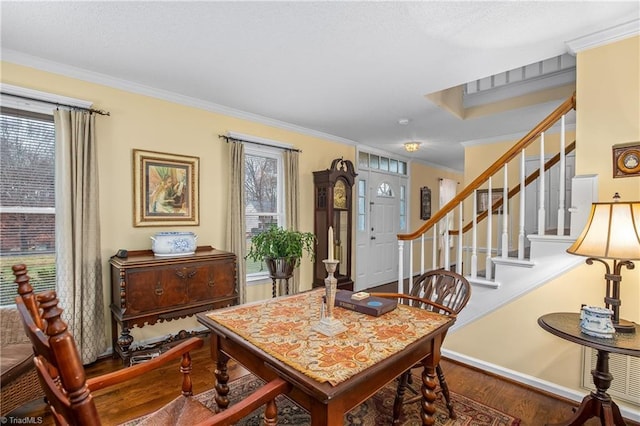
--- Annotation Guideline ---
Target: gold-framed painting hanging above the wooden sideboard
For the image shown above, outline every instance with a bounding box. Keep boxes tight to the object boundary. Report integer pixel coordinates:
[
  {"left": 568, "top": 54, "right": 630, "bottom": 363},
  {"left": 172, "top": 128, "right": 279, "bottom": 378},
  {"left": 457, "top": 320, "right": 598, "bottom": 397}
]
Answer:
[{"left": 133, "top": 149, "right": 200, "bottom": 227}]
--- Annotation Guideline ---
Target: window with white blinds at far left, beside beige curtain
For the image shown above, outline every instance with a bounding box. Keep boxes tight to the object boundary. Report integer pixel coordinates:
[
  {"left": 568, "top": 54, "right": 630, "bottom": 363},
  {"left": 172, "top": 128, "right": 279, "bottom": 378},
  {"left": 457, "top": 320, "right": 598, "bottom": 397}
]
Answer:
[{"left": 0, "top": 107, "right": 56, "bottom": 305}]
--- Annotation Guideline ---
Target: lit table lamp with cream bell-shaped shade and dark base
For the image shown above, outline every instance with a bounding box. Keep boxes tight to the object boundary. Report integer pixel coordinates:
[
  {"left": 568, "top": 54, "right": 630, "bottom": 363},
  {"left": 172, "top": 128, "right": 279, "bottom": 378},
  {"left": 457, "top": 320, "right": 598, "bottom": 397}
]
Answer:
[{"left": 567, "top": 192, "right": 640, "bottom": 333}]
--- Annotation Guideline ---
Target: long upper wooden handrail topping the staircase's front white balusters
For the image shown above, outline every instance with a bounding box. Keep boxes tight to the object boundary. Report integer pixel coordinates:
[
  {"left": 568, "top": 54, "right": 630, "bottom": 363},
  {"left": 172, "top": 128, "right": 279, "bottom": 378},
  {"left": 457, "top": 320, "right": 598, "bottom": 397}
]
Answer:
[{"left": 398, "top": 92, "right": 576, "bottom": 241}]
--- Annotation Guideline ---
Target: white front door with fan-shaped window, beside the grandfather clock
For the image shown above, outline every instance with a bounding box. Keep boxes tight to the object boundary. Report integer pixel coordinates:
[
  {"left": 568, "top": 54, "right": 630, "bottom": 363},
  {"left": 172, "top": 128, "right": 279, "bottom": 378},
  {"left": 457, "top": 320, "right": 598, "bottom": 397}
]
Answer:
[{"left": 354, "top": 171, "right": 406, "bottom": 291}]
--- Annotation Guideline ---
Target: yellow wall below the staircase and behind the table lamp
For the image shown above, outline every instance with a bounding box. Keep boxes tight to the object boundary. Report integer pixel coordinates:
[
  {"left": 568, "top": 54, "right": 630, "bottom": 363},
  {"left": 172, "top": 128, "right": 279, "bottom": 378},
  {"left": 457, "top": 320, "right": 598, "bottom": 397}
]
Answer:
[{"left": 445, "top": 37, "right": 640, "bottom": 410}]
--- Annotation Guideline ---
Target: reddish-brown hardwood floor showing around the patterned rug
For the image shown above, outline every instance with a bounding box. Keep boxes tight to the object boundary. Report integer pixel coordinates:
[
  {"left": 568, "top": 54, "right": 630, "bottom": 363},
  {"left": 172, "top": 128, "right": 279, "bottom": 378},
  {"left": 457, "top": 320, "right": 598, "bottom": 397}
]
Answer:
[{"left": 11, "top": 342, "right": 638, "bottom": 426}]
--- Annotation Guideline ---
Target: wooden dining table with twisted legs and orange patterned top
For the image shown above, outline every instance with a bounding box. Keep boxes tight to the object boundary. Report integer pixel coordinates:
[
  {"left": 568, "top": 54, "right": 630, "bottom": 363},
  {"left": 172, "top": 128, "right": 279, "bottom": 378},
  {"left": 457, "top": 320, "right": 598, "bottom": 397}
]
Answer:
[{"left": 197, "top": 289, "right": 455, "bottom": 426}]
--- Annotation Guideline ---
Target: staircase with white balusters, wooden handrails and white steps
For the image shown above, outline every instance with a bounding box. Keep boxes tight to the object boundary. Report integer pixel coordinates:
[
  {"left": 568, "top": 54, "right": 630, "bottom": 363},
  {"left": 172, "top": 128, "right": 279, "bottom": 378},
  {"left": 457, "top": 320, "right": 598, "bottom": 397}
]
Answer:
[{"left": 398, "top": 94, "right": 596, "bottom": 329}]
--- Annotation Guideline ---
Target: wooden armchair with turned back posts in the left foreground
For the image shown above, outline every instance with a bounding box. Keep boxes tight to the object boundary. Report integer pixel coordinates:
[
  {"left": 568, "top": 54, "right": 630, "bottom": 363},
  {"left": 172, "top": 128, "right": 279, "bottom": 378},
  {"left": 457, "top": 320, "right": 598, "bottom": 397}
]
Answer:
[{"left": 16, "top": 278, "right": 291, "bottom": 426}]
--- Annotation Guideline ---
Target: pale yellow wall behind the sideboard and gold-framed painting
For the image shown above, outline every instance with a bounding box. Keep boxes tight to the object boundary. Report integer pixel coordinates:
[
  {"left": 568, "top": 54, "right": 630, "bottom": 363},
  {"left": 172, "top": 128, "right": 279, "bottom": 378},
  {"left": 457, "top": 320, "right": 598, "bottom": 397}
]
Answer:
[{"left": 1, "top": 62, "right": 355, "bottom": 344}]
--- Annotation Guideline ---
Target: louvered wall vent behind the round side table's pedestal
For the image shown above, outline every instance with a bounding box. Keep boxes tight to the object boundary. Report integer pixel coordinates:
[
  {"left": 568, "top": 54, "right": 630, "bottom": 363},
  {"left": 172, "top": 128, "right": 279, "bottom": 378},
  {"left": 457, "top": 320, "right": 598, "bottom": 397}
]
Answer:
[{"left": 582, "top": 347, "right": 640, "bottom": 407}]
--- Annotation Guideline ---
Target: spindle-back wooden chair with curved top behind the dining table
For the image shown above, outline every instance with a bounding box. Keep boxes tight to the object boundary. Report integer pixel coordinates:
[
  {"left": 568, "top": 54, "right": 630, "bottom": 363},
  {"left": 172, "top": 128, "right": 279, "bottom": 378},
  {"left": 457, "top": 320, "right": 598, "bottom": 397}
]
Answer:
[{"left": 372, "top": 269, "right": 471, "bottom": 424}]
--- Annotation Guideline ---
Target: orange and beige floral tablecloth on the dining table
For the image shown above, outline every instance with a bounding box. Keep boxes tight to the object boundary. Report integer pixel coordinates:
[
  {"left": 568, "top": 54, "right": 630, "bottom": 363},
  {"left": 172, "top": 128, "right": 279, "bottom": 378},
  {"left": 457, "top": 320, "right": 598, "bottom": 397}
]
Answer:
[{"left": 207, "top": 289, "right": 452, "bottom": 385}]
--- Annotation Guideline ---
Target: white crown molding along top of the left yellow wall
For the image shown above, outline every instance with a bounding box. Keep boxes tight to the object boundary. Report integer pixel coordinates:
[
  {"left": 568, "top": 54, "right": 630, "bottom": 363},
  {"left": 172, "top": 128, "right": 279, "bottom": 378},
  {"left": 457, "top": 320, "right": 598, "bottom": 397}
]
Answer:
[{"left": 2, "top": 49, "right": 357, "bottom": 145}]
